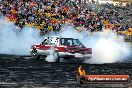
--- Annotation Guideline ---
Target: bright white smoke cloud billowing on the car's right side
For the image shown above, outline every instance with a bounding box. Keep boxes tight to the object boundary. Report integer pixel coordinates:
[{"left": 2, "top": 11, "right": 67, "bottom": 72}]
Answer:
[{"left": 60, "top": 26, "right": 132, "bottom": 63}]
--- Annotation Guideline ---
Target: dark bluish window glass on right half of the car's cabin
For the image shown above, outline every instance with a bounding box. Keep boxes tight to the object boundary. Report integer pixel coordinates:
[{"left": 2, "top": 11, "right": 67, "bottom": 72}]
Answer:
[{"left": 61, "top": 38, "right": 84, "bottom": 46}]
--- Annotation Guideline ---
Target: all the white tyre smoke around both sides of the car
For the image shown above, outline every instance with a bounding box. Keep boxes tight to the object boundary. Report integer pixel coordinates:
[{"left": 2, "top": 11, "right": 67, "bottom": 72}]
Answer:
[{"left": 0, "top": 19, "right": 132, "bottom": 63}]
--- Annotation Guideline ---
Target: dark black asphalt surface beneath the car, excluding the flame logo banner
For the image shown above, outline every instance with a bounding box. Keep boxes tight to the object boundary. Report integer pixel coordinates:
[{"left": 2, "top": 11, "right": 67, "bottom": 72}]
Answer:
[{"left": 0, "top": 55, "right": 132, "bottom": 88}]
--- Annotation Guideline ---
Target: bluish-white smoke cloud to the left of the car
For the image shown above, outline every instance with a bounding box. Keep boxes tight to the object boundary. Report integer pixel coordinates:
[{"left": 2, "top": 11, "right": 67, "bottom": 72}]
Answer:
[{"left": 0, "top": 18, "right": 42, "bottom": 55}]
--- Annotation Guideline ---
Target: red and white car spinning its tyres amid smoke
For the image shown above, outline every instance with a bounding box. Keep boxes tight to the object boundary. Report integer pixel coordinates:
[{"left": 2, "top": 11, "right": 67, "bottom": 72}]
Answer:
[{"left": 30, "top": 36, "right": 92, "bottom": 62}]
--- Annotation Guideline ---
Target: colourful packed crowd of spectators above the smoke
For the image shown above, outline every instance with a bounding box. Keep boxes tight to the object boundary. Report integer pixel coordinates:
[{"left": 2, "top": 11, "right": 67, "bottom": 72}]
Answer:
[{"left": 0, "top": 0, "right": 132, "bottom": 34}]
